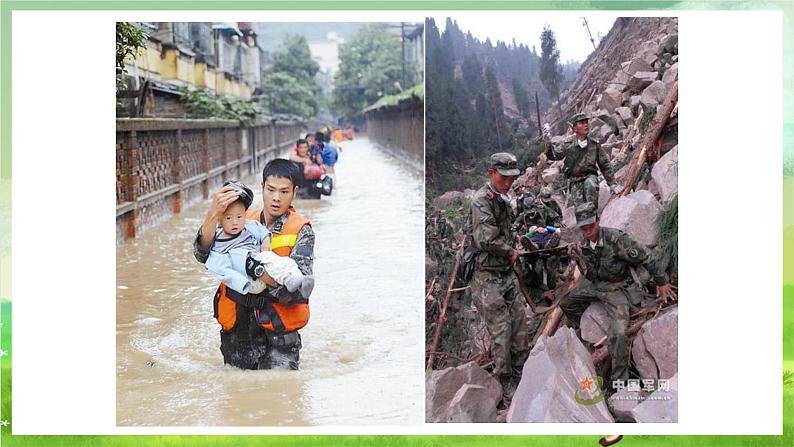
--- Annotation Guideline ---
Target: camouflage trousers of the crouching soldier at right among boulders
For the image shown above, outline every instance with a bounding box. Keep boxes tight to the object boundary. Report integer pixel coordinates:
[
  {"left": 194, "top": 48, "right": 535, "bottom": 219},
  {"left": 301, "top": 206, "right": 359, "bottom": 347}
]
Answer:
[{"left": 560, "top": 278, "right": 639, "bottom": 381}]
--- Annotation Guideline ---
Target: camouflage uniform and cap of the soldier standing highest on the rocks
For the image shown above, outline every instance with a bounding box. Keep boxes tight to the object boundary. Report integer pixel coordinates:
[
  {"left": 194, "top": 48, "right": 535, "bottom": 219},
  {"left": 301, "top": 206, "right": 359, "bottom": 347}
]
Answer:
[{"left": 546, "top": 113, "right": 615, "bottom": 214}]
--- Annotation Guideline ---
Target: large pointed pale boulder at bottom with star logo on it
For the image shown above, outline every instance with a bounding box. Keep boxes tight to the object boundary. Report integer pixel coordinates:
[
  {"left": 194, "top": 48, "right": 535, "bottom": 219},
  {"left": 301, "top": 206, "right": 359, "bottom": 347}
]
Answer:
[{"left": 507, "top": 327, "right": 614, "bottom": 422}]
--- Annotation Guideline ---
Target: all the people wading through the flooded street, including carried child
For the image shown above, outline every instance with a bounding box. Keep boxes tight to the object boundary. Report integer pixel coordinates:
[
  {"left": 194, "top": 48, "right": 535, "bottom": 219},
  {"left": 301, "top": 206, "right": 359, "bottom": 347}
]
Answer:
[{"left": 193, "top": 128, "right": 352, "bottom": 370}]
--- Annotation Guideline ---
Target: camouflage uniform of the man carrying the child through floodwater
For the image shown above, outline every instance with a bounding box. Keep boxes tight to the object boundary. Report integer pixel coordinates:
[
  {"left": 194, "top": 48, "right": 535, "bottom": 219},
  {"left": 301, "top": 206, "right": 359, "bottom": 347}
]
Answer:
[{"left": 193, "top": 210, "right": 314, "bottom": 369}]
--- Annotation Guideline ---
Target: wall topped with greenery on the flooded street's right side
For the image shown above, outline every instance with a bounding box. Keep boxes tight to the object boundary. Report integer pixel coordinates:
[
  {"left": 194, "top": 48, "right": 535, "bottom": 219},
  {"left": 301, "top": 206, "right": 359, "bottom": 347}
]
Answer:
[{"left": 366, "top": 98, "right": 425, "bottom": 163}]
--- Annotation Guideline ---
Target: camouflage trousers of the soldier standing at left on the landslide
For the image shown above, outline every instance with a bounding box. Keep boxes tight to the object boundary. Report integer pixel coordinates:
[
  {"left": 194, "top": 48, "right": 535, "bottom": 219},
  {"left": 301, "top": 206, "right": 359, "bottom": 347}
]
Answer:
[{"left": 471, "top": 270, "right": 537, "bottom": 380}]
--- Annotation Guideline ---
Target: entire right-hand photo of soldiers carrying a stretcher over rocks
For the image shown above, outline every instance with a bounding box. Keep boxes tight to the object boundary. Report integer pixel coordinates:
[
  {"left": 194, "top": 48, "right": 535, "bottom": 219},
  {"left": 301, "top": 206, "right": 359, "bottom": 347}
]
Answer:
[{"left": 425, "top": 12, "right": 679, "bottom": 423}]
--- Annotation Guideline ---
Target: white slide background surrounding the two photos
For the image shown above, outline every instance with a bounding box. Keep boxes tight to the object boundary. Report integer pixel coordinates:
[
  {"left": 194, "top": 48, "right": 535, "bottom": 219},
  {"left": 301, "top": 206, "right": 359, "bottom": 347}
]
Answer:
[{"left": 12, "top": 11, "right": 783, "bottom": 435}]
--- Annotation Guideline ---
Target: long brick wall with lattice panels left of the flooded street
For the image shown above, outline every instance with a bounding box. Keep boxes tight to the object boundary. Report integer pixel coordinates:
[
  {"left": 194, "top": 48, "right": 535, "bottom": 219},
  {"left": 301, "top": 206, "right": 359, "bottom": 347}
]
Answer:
[{"left": 116, "top": 118, "right": 303, "bottom": 243}]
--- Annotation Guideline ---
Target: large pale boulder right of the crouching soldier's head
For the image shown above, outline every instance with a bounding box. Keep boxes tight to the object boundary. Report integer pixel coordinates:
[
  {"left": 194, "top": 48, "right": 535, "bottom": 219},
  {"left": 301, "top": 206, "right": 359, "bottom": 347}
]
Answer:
[{"left": 601, "top": 190, "right": 662, "bottom": 246}]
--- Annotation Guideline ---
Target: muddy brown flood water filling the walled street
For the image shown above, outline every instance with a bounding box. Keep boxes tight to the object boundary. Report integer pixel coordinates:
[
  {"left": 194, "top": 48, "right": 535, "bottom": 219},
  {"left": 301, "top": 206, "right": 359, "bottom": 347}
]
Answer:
[{"left": 116, "top": 138, "right": 424, "bottom": 426}]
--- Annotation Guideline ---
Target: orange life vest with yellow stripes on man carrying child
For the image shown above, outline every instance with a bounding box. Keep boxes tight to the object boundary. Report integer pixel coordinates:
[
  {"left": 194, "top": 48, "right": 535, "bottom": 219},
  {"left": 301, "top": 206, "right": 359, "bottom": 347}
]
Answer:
[{"left": 214, "top": 207, "right": 311, "bottom": 333}]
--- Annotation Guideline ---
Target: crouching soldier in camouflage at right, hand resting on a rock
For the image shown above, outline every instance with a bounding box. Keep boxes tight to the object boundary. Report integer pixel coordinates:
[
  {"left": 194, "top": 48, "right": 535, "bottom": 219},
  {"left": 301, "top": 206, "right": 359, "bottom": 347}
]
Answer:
[{"left": 560, "top": 204, "right": 672, "bottom": 382}]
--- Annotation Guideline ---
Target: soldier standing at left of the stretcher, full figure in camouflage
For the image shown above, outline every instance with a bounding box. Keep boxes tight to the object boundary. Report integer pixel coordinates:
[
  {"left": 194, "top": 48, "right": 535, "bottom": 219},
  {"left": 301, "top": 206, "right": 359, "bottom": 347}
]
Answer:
[{"left": 471, "top": 152, "right": 539, "bottom": 395}]
